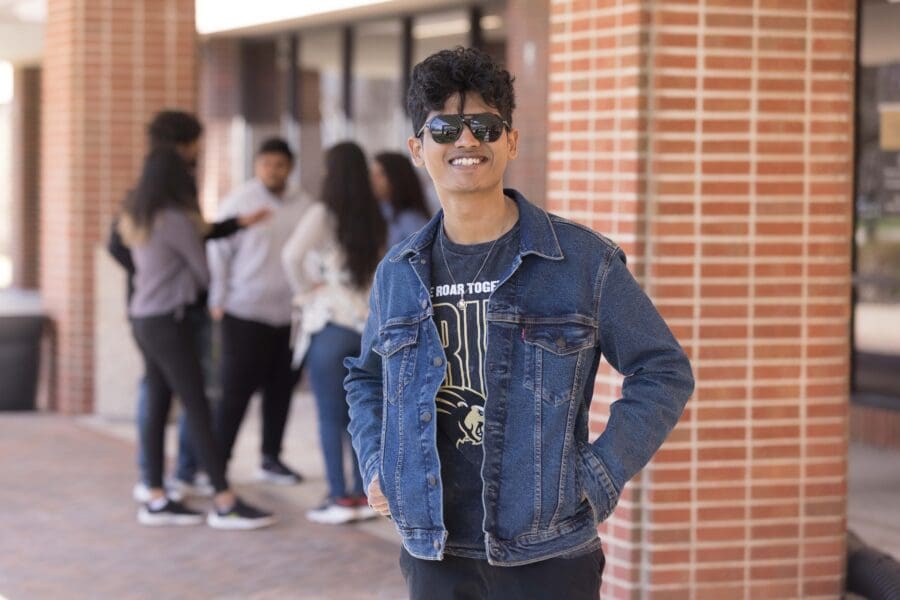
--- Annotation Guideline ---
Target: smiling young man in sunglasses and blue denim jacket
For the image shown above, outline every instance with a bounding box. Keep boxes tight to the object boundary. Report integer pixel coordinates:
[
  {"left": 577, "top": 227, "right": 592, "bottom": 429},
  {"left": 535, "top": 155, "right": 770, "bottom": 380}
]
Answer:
[{"left": 345, "top": 48, "right": 693, "bottom": 599}]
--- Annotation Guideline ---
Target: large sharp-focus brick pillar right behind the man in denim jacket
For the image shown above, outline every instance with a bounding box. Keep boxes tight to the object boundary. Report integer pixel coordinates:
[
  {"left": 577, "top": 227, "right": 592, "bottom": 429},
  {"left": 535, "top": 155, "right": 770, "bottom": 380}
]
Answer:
[{"left": 548, "top": 0, "right": 855, "bottom": 599}]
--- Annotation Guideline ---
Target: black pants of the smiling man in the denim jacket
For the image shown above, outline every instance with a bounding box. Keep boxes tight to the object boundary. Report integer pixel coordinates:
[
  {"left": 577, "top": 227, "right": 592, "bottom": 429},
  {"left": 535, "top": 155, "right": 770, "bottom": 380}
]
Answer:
[{"left": 400, "top": 548, "right": 606, "bottom": 600}]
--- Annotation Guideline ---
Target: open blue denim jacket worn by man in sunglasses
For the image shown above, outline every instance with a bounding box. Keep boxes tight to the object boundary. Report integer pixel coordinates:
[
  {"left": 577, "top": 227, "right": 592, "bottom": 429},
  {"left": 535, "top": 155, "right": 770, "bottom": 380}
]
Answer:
[{"left": 344, "top": 189, "right": 694, "bottom": 566}]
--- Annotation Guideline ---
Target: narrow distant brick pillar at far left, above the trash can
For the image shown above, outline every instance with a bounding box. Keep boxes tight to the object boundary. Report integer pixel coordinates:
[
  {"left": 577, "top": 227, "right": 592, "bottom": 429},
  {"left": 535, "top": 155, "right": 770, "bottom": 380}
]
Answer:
[{"left": 10, "top": 66, "right": 41, "bottom": 289}]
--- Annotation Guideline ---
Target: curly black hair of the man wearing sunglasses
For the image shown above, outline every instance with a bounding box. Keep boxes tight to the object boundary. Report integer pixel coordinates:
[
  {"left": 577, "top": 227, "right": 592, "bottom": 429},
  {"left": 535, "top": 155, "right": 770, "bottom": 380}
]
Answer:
[{"left": 406, "top": 46, "right": 516, "bottom": 135}]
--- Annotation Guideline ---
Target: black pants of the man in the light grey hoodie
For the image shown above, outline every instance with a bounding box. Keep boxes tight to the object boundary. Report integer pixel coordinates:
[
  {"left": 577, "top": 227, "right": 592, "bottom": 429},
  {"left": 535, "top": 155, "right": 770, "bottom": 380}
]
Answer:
[{"left": 216, "top": 314, "right": 300, "bottom": 462}]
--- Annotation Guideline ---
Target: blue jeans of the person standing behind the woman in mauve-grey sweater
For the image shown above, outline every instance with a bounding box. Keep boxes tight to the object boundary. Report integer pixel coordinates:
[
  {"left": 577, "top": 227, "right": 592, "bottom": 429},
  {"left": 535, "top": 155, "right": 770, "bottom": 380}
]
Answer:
[{"left": 136, "top": 305, "right": 215, "bottom": 483}]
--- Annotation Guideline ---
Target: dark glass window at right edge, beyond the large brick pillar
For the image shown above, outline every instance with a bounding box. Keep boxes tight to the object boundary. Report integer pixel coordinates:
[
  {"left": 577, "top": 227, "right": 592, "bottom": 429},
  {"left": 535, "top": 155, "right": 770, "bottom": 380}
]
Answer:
[{"left": 853, "top": 0, "right": 900, "bottom": 410}]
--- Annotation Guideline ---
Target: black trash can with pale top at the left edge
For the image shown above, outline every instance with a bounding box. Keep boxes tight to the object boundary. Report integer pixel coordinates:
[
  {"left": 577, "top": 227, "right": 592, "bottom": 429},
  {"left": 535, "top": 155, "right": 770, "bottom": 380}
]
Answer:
[{"left": 0, "top": 292, "right": 45, "bottom": 411}]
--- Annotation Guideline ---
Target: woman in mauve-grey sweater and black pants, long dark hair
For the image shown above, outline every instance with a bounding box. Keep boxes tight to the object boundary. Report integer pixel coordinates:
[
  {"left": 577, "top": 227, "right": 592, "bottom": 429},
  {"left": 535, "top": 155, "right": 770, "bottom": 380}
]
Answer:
[{"left": 119, "top": 148, "right": 274, "bottom": 529}]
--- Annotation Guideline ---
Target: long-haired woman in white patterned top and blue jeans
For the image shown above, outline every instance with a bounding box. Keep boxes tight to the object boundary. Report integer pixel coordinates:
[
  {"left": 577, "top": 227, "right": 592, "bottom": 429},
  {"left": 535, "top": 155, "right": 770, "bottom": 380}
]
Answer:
[{"left": 282, "top": 142, "right": 387, "bottom": 524}]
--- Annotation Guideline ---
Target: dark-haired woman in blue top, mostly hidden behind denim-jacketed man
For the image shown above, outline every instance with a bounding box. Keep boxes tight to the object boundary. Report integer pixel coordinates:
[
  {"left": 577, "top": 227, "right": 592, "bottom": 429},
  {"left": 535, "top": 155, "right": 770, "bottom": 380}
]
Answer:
[{"left": 372, "top": 152, "right": 431, "bottom": 248}]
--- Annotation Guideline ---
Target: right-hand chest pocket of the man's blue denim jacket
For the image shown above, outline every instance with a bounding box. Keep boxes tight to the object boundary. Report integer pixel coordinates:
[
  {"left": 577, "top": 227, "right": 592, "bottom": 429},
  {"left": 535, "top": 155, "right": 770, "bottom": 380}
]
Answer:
[{"left": 523, "top": 321, "right": 597, "bottom": 406}]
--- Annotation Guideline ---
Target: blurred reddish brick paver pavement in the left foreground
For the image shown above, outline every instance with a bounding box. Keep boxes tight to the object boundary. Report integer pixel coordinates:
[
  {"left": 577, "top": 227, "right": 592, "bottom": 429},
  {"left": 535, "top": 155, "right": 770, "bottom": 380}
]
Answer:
[{"left": 0, "top": 413, "right": 405, "bottom": 600}]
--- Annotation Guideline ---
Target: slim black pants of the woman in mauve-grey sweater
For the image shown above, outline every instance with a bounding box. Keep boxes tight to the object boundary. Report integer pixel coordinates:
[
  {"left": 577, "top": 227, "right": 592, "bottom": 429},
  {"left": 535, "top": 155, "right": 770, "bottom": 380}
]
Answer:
[{"left": 131, "top": 314, "right": 228, "bottom": 492}]
